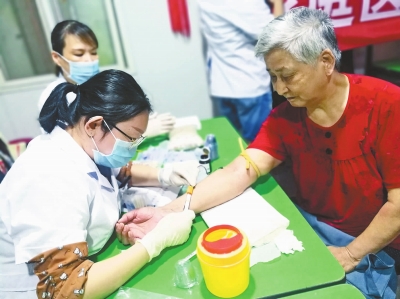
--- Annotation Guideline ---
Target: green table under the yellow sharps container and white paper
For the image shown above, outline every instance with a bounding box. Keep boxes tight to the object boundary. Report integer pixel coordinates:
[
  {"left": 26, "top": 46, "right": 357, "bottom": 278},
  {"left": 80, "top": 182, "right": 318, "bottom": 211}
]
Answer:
[{"left": 94, "top": 118, "right": 345, "bottom": 299}]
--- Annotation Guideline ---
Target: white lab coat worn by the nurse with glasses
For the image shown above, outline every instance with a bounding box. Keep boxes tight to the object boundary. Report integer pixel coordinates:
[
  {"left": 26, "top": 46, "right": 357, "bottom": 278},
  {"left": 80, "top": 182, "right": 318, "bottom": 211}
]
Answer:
[{"left": 0, "top": 126, "right": 120, "bottom": 298}]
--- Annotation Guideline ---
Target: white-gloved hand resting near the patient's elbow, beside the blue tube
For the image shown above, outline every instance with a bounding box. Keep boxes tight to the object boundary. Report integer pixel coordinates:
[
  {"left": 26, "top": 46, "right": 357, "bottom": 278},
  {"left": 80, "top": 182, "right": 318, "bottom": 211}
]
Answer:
[{"left": 158, "top": 160, "right": 199, "bottom": 187}]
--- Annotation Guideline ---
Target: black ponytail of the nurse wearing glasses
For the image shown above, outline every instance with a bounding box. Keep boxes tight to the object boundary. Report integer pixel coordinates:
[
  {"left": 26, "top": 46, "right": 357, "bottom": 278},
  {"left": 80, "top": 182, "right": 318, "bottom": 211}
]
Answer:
[{"left": 39, "top": 82, "right": 80, "bottom": 133}]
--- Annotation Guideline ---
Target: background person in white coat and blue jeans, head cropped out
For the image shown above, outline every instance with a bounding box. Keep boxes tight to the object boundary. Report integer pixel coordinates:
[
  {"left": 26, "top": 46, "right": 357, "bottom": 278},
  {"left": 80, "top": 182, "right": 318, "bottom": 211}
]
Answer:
[{"left": 198, "top": 0, "right": 283, "bottom": 141}]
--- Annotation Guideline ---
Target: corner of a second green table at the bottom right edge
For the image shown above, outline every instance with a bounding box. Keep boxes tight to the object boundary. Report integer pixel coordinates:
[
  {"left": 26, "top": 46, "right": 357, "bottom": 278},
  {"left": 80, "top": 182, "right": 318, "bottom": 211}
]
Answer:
[{"left": 280, "top": 284, "right": 365, "bottom": 299}]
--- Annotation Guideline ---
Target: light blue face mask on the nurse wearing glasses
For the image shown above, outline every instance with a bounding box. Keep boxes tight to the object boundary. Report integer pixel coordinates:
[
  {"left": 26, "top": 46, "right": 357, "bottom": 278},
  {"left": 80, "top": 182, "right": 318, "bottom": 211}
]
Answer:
[{"left": 92, "top": 121, "right": 137, "bottom": 168}]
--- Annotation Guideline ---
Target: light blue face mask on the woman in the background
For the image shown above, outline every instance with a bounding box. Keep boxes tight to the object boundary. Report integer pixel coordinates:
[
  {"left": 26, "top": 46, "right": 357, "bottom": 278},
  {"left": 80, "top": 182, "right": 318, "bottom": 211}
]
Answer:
[{"left": 57, "top": 53, "right": 100, "bottom": 84}]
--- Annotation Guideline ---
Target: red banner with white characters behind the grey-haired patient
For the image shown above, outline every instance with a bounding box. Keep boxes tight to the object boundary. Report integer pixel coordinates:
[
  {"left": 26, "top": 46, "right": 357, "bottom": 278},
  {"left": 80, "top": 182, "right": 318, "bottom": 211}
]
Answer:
[{"left": 285, "top": 0, "right": 400, "bottom": 51}]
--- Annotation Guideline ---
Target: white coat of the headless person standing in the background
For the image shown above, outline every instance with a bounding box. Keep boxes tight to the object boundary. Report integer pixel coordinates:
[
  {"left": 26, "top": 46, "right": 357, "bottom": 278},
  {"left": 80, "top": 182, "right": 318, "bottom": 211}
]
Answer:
[{"left": 198, "top": 0, "right": 274, "bottom": 98}]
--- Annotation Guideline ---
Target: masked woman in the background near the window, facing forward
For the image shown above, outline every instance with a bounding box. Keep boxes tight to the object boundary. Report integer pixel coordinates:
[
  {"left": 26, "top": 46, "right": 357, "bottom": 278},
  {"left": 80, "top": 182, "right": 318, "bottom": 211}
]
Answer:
[{"left": 38, "top": 20, "right": 175, "bottom": 137}]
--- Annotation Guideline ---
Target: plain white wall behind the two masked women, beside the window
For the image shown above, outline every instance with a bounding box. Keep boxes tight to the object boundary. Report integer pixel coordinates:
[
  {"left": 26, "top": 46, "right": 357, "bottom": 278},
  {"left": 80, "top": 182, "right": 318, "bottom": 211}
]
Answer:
[{"left": 0, "top": 0, "right": 212, "bottom": 139}]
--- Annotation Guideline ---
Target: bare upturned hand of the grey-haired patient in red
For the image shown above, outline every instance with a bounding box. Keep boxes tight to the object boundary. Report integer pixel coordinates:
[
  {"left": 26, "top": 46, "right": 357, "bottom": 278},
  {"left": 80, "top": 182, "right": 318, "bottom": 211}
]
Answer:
[{"left": 115, "top": 207, "right": 172, "bottom": 245}]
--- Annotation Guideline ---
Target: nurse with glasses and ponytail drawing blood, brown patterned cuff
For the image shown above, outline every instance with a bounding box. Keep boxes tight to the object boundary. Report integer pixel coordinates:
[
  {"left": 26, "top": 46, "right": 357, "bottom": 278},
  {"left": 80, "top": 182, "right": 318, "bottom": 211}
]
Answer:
[{"left": 0, "top": 70, "right": 194, "bottom": 298}]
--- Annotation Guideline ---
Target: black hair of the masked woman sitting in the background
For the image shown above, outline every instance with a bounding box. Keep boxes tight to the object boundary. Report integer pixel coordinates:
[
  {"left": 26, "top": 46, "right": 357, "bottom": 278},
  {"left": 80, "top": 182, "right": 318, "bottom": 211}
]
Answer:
[{"left": 51, "top": 20, "right": 99, "bottom": 76}]
